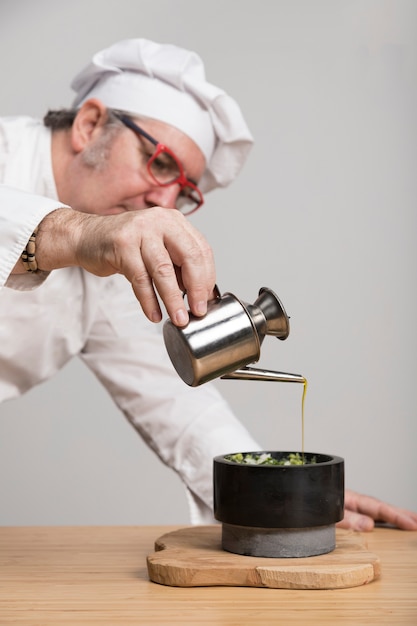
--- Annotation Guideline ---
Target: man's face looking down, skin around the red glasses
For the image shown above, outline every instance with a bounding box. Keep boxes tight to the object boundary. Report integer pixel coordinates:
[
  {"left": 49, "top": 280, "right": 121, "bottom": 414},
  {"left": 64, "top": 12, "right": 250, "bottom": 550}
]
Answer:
[{"left": 57, "top": 114, "right": 205, "bottom": 215}]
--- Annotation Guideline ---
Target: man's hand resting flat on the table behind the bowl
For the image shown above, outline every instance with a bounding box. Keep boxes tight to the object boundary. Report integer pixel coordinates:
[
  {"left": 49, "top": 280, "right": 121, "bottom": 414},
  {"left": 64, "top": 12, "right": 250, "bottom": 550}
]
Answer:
[{"left": 337, "top": 489, "right": 417, "bottom": 531}]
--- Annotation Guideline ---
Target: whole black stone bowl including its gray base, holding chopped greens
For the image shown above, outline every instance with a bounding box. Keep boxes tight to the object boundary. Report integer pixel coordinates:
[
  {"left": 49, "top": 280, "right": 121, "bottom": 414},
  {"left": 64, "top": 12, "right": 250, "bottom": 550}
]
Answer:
[{"left": 213, "top": 451, "right": 344, "bottom": 557}]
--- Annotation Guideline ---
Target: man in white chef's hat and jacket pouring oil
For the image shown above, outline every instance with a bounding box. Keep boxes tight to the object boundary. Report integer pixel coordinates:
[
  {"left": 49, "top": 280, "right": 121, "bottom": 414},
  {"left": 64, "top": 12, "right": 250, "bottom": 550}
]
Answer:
[{"left": 0, "top": 39, "right": 417, "bottom": 530}]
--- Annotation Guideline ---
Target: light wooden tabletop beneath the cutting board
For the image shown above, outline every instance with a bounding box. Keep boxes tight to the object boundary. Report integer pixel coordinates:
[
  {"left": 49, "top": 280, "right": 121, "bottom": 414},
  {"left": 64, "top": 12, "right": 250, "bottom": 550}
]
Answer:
[{"left": 0, "top": 526, "right": 417, "bottom": 626}]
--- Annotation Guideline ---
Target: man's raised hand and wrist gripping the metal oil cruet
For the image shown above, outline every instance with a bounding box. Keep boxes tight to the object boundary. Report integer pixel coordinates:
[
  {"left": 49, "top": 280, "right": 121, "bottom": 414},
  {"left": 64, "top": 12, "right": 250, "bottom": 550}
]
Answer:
[{"left": 36, "top": 207, "right": 216, "bottom": 326}]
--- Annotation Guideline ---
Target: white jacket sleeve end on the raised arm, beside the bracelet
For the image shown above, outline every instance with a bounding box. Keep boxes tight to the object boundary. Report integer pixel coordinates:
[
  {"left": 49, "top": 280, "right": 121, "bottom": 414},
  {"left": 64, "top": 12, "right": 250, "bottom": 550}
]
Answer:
[{"left": 0, "top": 185, "right": 63, "bottom": 290}]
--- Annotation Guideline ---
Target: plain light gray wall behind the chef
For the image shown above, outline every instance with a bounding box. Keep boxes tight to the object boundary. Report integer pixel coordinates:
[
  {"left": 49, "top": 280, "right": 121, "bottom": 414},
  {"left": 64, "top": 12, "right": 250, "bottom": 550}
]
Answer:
[{"left": 0, "top": 0, "right": 417, "bottom": 525}]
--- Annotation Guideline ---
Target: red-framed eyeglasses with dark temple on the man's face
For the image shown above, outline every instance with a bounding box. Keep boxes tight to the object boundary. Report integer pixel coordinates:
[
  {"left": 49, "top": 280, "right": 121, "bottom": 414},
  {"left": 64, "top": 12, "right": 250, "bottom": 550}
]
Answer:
[{"left": 115, "top": 114, "right": 204, "bottom": 215}]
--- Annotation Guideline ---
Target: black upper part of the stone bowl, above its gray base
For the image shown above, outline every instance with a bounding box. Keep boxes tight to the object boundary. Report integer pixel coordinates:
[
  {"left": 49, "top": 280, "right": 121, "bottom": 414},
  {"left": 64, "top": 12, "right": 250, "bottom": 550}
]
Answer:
[{"left": 213, "top": 451, "right": 344, "bottom": 528}]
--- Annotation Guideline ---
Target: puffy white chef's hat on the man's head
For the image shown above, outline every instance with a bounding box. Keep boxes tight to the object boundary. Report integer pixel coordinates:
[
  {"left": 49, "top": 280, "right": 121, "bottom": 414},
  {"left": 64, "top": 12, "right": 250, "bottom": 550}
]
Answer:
[{"left": 71, "top": 39, "right": 253, "bottom": 192}]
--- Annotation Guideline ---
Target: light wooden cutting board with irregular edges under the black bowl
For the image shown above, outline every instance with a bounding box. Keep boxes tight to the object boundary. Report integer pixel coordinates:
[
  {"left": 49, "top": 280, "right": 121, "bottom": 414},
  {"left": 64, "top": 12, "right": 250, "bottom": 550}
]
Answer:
[{"left": 147, "top": 525, "right": 380, "bottom": 589}]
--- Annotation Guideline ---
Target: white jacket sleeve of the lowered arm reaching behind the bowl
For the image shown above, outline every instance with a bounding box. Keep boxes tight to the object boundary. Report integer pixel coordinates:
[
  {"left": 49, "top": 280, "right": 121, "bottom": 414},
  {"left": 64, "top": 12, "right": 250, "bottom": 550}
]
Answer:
[{"left": 81, "top": 276, "right": 260, "bottom": 522}]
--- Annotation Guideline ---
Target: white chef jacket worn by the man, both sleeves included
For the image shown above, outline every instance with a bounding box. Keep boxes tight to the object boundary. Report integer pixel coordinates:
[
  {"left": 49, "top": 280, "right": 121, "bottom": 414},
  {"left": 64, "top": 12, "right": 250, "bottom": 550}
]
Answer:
[{"left": 0, "top": 117, "right": 260, "bottom": 523}]
